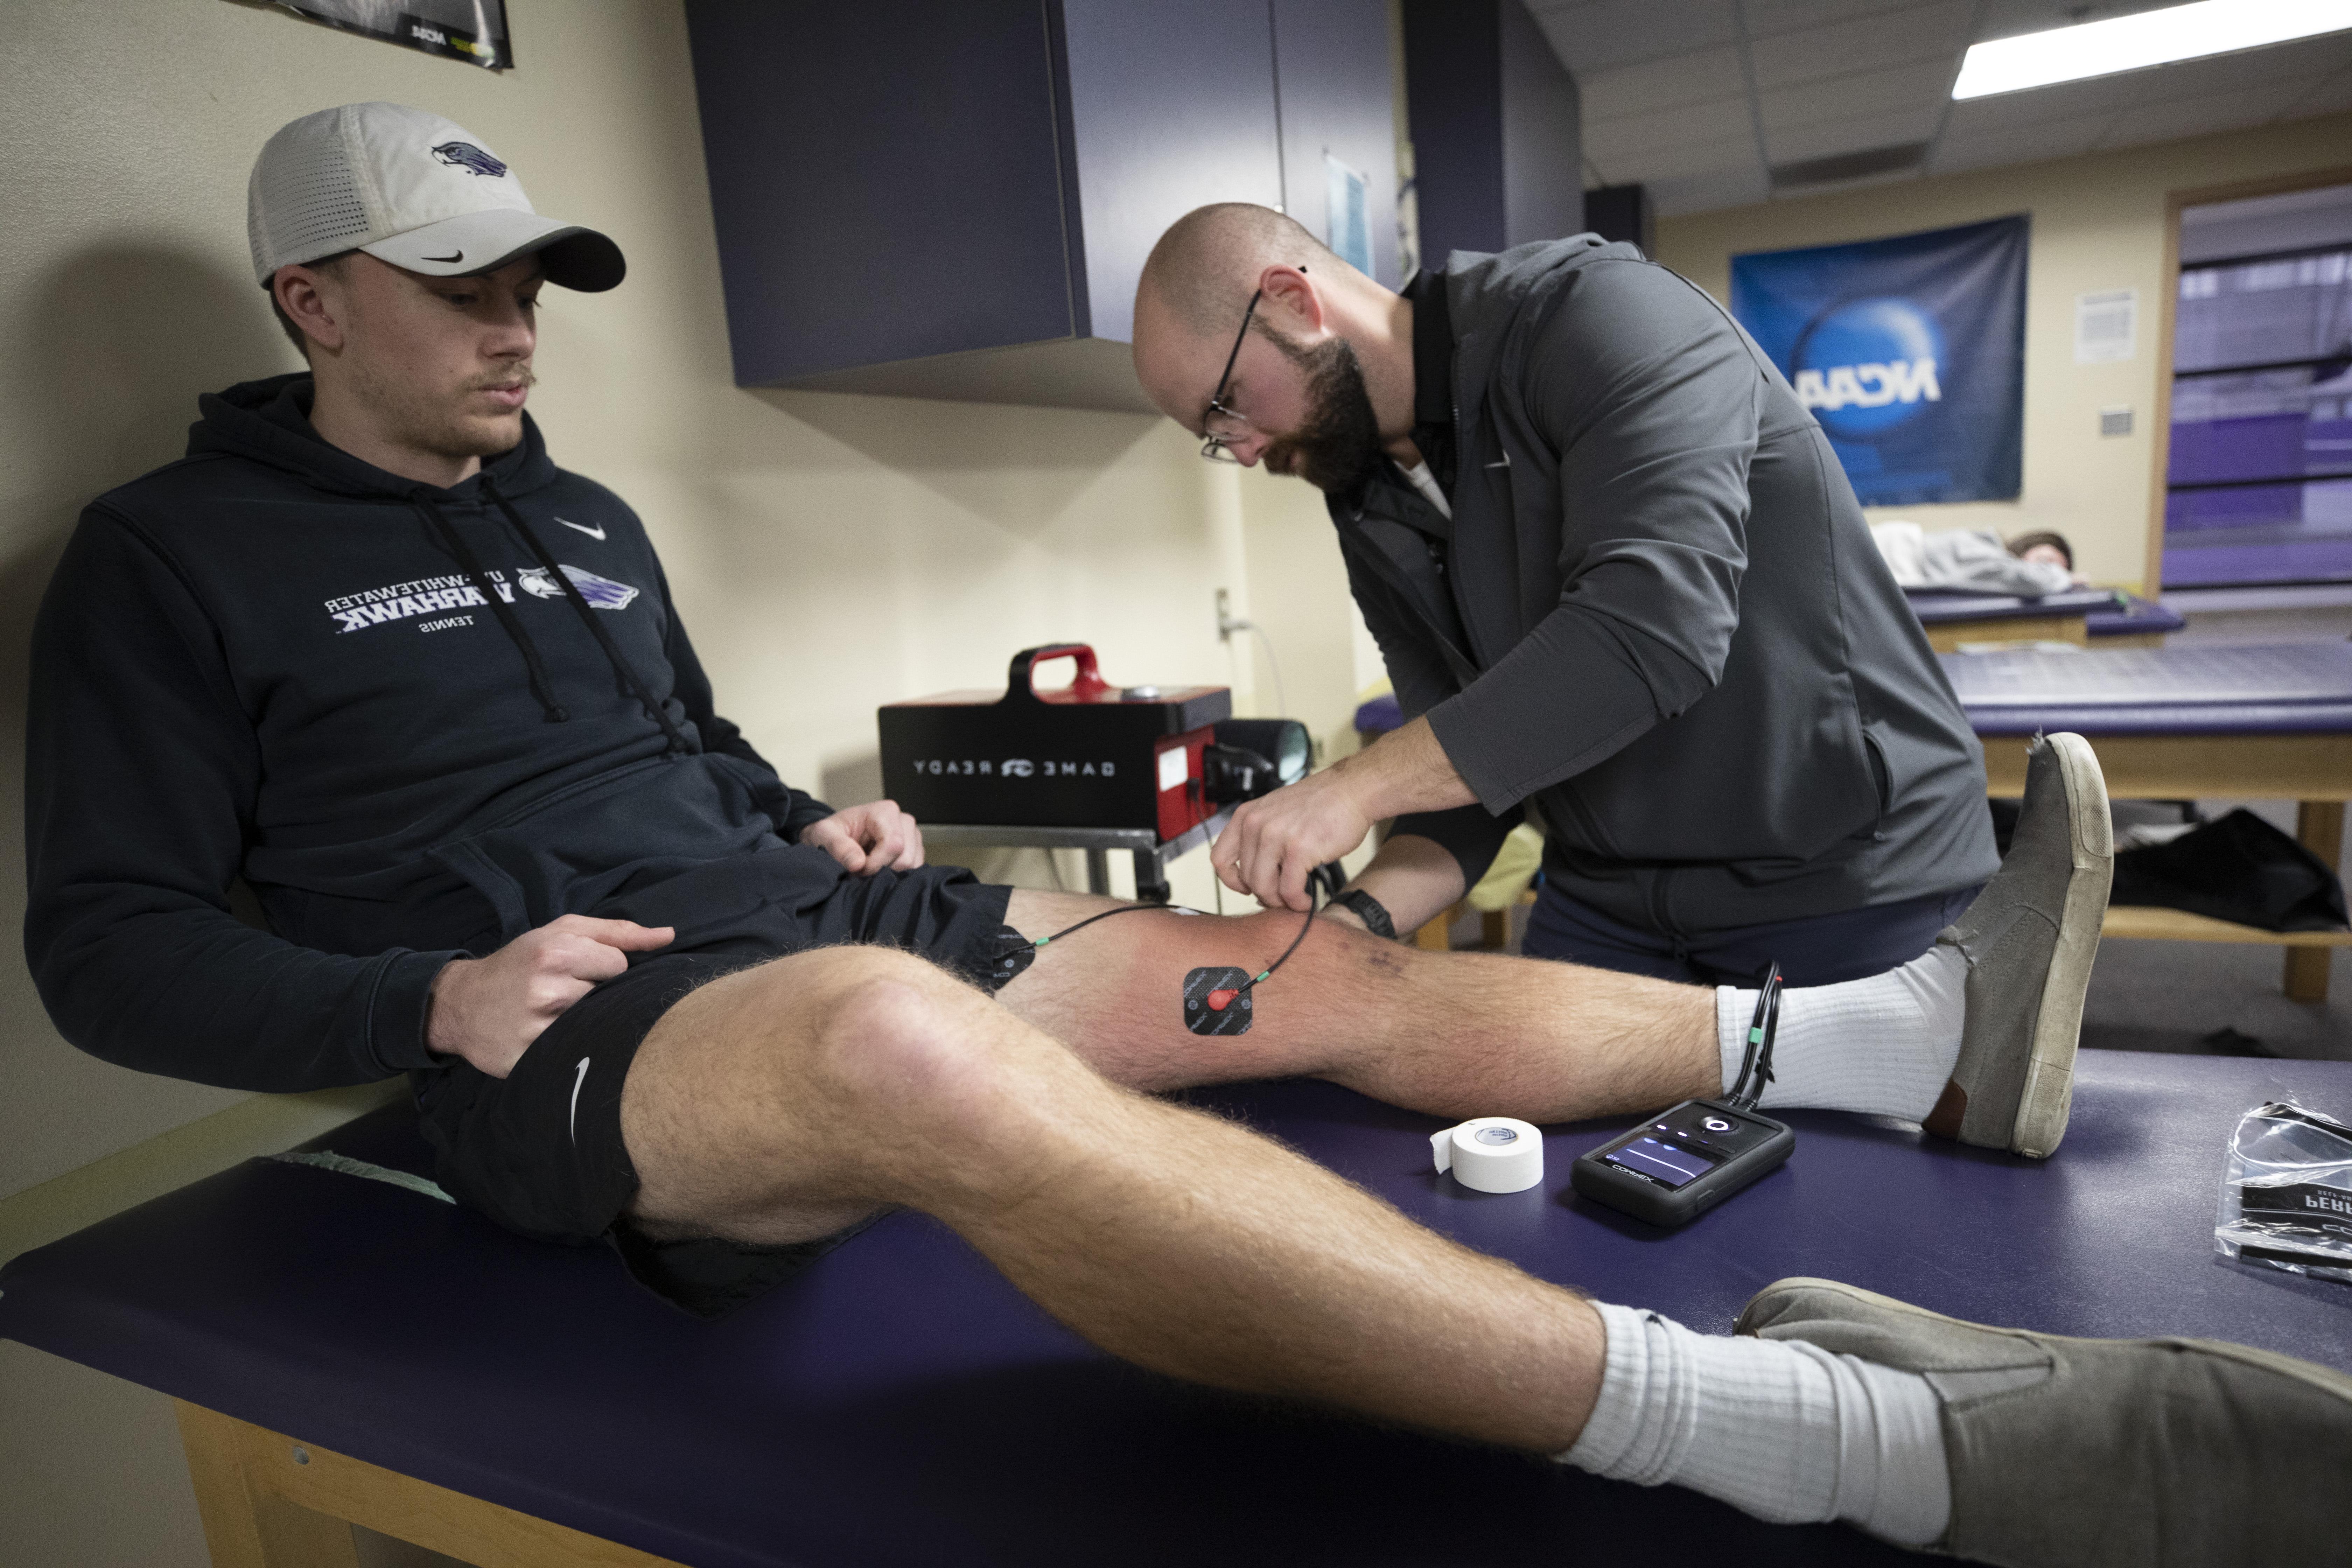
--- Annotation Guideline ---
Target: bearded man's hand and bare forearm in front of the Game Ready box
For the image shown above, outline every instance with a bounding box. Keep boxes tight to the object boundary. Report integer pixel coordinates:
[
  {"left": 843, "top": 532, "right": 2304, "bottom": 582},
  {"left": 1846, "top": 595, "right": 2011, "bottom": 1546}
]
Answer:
[{"left": 1209, "top": 719, "right": 1477, "bottom": 910}]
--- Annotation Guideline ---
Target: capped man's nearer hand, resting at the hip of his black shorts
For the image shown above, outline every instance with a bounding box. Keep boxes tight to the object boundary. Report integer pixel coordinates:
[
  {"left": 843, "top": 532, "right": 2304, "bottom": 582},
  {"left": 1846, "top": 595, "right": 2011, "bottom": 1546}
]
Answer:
[{"left": 426, "top": 915, "right": 675, "bottom": 1079}]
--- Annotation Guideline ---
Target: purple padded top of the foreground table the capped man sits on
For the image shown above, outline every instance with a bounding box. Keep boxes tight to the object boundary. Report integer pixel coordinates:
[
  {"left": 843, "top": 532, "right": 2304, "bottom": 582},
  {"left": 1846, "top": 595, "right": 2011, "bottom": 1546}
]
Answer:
[{"left": 0, "top": 1051, "right": 2352, "bottom": 1568}]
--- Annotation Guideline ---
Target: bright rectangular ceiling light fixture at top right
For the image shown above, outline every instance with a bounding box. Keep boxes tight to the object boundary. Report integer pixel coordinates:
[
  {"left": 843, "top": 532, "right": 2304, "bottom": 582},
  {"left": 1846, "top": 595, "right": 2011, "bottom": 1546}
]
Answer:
[{"left": 1952, "top": 0, "right": 2352, "bottom": 99}]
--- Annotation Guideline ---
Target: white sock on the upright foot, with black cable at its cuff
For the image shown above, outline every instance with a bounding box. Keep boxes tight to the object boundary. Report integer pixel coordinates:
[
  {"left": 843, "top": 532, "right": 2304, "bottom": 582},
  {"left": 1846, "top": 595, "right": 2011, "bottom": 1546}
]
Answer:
[{"left": 1715, "top": 947, "right": 1969, "bottom": 1121}]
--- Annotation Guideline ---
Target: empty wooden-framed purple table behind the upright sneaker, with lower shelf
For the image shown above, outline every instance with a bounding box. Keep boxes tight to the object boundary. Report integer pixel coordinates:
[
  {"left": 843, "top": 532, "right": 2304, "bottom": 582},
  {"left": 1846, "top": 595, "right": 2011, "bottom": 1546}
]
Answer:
[{"left": 1943, "top": 642, "right": 2352, "bottom": 1001}]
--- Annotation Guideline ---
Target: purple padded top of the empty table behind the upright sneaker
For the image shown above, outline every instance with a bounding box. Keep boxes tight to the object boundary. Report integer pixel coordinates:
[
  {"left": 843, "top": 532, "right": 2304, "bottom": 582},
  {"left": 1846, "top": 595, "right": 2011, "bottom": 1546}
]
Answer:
[{"left": 1938, "top": 642, "right": 2352, "bottom": 708}]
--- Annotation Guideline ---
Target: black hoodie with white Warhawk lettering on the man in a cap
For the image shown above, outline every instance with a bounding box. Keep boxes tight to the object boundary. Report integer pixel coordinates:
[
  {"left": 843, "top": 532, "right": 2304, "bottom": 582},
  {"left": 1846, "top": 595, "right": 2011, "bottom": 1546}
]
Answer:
[{"left": 23, "top": 374, "right": 828, "bottom": 1091}]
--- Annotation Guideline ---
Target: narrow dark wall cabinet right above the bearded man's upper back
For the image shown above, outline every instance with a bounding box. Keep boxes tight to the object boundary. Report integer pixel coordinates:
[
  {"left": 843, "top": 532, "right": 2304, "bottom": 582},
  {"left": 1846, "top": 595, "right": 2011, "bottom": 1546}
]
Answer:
[{"left": 1404, "top": 0, "right": 1585, "bottom": 266}]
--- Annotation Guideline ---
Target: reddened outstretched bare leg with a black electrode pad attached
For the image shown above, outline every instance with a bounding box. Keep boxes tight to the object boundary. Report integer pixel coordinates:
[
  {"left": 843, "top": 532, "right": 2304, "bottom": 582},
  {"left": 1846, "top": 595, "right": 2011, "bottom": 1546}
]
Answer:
[{"left": 1002, "top": 889, "right": 1722, "bottom": 1121}]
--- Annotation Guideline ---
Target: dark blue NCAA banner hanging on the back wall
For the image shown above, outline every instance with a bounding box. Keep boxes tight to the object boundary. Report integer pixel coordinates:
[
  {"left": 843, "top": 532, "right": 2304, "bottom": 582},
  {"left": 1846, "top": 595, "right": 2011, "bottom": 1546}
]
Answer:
[{"left": 1731, "top": 216, "right": 2028, "bottom": 505}]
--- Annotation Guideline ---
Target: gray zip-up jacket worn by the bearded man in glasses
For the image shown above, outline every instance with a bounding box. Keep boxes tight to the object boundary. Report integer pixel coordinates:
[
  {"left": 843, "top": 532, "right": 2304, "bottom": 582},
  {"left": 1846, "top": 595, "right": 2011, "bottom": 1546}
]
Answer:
[{"left": 1331, "top": 235, "right": 1999, "bottom": 933}]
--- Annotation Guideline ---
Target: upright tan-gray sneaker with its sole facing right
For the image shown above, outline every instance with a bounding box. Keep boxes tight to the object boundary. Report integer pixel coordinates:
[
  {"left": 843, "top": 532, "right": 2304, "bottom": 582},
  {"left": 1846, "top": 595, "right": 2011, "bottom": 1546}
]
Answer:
[{"left": 1926, "top": 734, "right": 2114, "bottom": 1159}]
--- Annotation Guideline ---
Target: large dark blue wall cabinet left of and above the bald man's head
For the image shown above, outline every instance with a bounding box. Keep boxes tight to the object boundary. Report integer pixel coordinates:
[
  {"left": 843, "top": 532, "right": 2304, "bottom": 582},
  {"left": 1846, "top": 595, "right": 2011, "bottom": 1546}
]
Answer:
[{"left": 687, "top": 0, "right": 1397, "bottom": 409}]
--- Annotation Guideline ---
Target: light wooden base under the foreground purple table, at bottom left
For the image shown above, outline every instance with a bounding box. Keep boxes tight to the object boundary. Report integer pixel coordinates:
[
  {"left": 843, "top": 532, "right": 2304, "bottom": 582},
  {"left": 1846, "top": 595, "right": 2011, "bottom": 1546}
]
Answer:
[{"left": 174, "top": 1399, "right": 680, "bottom": 1568}]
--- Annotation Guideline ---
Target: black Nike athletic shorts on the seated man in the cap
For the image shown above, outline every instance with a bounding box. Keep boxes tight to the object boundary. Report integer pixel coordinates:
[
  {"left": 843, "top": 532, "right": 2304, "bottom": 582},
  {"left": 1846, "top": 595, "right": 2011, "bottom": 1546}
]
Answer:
[{"left": 412, "top": 846, "right": 1028, "bottom": 1316}]
